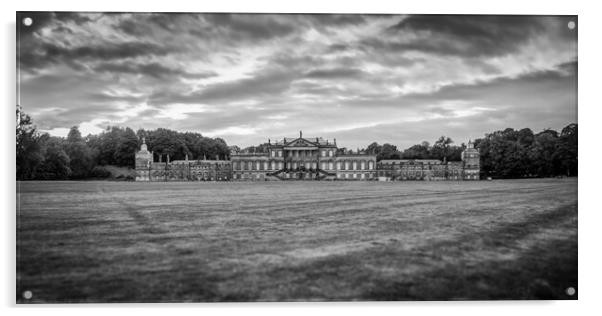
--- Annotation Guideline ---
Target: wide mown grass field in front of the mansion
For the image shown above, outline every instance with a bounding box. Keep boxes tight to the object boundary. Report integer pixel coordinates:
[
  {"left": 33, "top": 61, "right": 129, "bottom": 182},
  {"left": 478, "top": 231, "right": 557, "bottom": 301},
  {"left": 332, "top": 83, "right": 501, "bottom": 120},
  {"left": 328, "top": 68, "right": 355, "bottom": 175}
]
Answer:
[{"left": 17, "top": 179, "right": 578, "bottom": 303}]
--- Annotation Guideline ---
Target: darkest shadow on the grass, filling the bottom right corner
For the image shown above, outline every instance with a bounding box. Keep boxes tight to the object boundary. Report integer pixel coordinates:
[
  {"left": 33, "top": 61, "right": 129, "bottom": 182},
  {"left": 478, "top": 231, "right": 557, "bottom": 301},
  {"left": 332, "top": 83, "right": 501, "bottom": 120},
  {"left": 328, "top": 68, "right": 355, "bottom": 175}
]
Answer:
[{"left": 362, "top": 239, "right": 577, "bottom": 301}]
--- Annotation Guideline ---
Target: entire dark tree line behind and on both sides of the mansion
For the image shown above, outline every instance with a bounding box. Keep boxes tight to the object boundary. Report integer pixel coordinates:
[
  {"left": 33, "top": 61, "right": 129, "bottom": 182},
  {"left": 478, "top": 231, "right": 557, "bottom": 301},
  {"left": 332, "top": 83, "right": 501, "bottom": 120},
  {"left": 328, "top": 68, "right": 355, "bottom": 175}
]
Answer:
[{"left": 16, "top": 109, "right": 577, "bottom": 180}]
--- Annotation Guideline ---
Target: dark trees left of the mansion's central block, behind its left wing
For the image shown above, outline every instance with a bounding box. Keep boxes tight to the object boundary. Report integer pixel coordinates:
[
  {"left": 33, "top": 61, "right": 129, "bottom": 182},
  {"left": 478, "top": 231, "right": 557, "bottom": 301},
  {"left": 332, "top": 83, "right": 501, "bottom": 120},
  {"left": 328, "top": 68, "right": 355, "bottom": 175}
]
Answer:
[{"left": 16, "top": 109, "right": 230, "bottom": 180}]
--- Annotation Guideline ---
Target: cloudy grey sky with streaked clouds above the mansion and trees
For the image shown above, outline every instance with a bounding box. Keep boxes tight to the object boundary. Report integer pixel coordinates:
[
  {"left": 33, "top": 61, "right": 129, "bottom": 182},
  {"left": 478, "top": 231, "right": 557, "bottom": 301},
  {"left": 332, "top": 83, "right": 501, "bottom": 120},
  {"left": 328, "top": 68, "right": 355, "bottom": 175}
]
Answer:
[{"left": 17, "top": 13, "right": 578, "bottom": 149}]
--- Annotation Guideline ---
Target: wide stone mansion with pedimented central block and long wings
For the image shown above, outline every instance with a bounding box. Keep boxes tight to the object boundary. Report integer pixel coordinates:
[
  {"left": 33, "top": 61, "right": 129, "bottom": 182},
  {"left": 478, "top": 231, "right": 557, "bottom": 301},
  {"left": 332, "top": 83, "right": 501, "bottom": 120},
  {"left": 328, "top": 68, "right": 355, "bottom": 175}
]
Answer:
[{"left": 136, "top": 132, "right": 480, "bottom": 181}]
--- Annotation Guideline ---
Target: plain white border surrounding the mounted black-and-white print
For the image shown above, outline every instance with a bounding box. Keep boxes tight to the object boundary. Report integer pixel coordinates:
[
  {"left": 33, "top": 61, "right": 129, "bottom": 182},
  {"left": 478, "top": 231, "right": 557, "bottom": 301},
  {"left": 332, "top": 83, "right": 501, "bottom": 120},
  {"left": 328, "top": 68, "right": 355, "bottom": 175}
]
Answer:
[{"left": 0, "top": 0, "right": 602, "bottom": 316}]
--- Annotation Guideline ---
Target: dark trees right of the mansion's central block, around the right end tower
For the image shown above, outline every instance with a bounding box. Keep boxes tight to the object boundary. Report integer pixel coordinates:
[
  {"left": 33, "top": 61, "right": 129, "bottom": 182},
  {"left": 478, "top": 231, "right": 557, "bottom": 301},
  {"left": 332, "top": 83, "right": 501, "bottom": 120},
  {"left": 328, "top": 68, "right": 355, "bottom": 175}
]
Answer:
[{"left": 358, "top": 123, "right": 578, "bottom": 178}]
